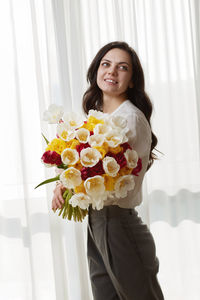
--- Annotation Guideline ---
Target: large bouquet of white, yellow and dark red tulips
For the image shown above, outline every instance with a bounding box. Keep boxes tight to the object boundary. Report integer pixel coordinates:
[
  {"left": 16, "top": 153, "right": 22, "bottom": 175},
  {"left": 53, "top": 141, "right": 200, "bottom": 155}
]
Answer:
[{"left": 36, "top": 104, "right": 142, "bottom": 221}]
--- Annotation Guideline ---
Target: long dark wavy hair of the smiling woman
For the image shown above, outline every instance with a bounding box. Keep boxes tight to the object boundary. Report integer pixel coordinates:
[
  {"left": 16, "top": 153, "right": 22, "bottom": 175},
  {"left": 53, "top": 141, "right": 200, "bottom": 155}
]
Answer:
[{"left": 82, "top": 41, "right": 162, "bottom": 171}]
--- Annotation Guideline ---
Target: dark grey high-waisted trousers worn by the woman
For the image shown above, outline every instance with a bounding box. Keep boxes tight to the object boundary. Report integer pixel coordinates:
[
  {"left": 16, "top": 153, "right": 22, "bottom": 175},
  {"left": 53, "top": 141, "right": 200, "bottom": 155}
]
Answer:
[{"left": 87, "top": 205, "right": 164, "bottom": 300}]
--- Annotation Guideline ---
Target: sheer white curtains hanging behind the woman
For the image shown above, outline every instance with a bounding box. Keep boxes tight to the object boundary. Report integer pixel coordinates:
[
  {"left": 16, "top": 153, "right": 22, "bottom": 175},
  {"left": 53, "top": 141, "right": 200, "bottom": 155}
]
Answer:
[{"left": 0, "top": 0, "right": 200, "bottom": 300}]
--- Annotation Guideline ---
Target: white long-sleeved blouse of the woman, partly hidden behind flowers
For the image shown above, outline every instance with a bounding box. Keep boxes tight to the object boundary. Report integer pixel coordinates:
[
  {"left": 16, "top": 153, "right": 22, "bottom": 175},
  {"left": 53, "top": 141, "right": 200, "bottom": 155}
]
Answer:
[{"left": 104, "top": 100, "right": 152, "bottom": 208}]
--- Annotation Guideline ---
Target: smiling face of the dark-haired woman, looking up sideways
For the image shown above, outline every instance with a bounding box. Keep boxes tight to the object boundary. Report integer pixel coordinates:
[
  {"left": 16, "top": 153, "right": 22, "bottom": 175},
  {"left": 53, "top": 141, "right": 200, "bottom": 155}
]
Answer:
[{"left": 97, "top": 48, "right": 133, "bottom": 98}]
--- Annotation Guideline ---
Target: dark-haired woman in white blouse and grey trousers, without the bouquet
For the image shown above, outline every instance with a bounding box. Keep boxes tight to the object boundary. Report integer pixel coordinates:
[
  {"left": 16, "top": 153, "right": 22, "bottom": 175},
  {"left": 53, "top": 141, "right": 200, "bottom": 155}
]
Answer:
[{"left": 52, "top": 42, "right": 164, "bottom": 300}]
